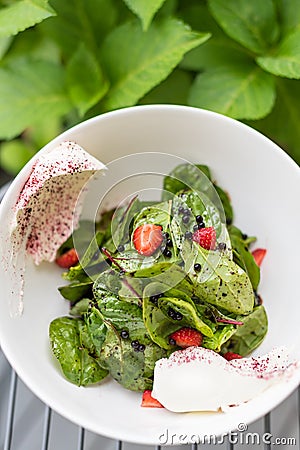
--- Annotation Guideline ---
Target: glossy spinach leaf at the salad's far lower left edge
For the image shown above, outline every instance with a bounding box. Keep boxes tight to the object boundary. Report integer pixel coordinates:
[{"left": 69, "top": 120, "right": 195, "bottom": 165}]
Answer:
[{"left": 49, "top": 317, "right": 108, "bottom": 386}]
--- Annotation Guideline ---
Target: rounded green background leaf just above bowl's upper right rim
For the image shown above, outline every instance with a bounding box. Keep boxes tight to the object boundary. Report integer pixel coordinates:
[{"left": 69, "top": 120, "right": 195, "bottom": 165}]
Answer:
[{"left": 189, "top": 60, "right": 276, "bottom": 119}]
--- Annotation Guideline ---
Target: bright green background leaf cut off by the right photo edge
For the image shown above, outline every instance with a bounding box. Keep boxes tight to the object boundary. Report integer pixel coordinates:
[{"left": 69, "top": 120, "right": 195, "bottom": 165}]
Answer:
[{"left": 256, "top": 28, "right": 300, "bottom": 79}]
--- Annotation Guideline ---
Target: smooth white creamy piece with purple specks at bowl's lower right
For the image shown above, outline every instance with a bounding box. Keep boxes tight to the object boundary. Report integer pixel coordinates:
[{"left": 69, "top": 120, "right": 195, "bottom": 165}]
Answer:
[{"left": 152, "top": 347, "right": 299, "bottom": 412}]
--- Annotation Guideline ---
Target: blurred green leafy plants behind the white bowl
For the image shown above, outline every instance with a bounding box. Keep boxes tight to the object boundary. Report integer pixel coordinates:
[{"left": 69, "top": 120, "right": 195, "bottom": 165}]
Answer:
[{"left": 0, "top": 0, "right": 300, "bottom": 175}]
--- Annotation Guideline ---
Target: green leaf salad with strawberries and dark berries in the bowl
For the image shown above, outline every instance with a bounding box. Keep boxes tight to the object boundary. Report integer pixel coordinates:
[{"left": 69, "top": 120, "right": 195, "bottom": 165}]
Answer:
[{"left": 49, "top": 164, "right": 268, "bottom": 391}]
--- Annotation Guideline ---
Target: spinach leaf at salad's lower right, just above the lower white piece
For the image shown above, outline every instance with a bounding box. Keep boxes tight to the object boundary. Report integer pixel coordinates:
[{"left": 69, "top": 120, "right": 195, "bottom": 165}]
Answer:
[{"left": 222, "top": 305, "right": 268, "bottom": 356}]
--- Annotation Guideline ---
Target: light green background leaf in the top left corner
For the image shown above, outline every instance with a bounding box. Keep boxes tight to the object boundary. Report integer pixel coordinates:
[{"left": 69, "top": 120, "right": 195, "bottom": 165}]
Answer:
[{"left": 0, "top": 0, "right": 55, "bottom": 37}]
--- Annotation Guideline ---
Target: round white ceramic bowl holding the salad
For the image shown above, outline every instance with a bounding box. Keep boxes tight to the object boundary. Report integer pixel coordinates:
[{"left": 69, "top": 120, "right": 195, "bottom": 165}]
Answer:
[{"left": 0, "top": 105, "right": 300, "bottom": 444}]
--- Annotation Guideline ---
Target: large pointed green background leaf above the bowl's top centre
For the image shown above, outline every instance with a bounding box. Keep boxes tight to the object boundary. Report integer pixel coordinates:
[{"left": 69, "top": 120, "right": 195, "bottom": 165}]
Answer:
[{"left": 101, "top": 18, "right": 209, "bottom": 109}]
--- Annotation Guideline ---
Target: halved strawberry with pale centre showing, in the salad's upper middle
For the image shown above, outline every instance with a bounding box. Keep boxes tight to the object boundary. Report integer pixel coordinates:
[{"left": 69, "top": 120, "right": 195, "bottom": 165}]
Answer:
[{"left": 133, "top": 223, "right": 164, "bottom": 256}]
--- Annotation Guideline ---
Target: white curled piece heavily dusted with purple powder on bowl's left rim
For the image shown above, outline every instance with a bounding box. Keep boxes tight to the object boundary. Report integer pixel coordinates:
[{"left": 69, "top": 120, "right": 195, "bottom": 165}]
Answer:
[{"left": 9, "top": 141, "right": 105, "bottom": 315}]
